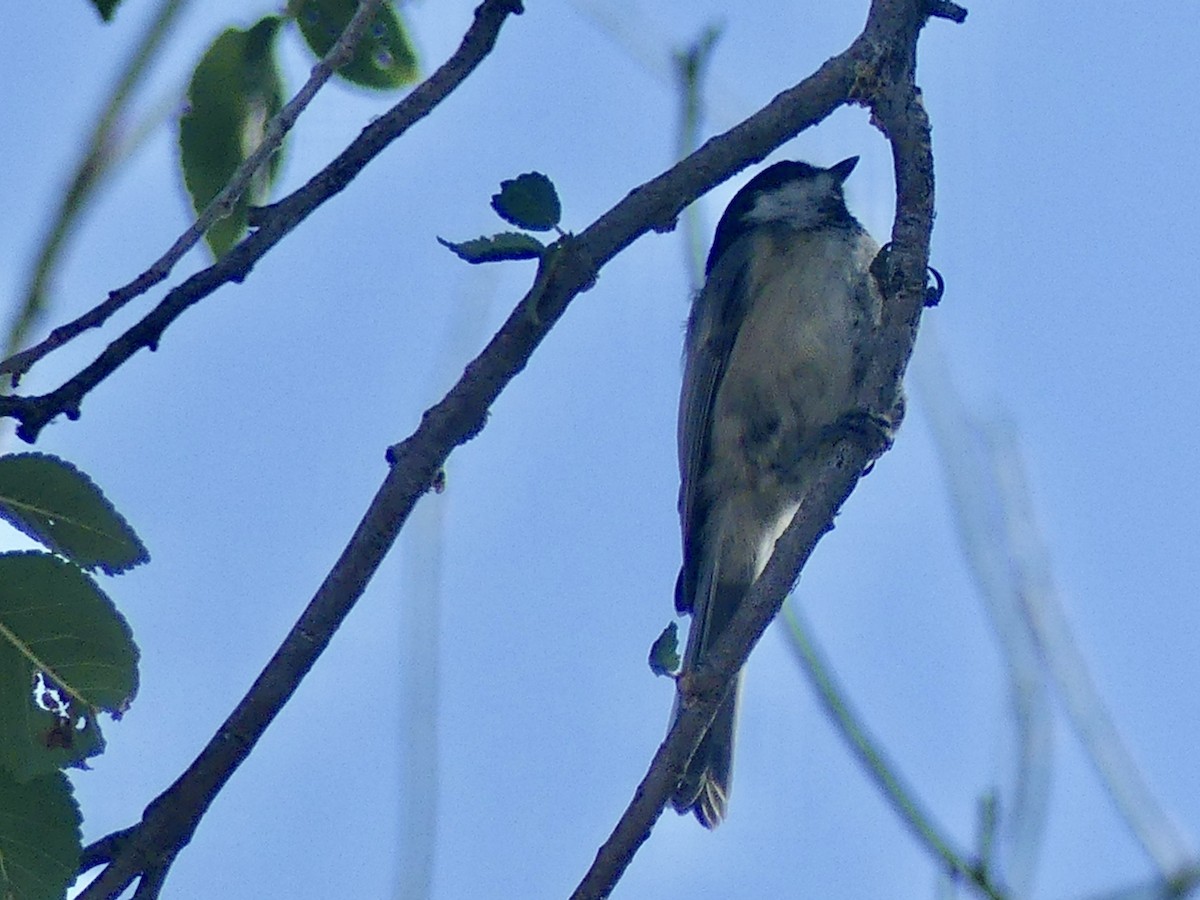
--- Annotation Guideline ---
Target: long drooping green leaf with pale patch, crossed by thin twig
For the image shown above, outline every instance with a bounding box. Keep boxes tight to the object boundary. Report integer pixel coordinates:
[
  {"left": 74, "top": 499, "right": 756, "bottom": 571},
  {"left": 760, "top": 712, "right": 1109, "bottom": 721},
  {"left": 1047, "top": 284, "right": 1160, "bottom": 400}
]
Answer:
[{"left": 179, "top": 16, "right": 283, "bottom": 257}]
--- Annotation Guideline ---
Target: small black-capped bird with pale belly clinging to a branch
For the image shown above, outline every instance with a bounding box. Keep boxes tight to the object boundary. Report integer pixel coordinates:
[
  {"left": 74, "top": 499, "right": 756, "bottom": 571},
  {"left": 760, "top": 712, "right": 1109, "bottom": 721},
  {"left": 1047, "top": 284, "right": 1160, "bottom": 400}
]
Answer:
[{"left": 672, "top": 156, "right": 882, "bottom": 828}]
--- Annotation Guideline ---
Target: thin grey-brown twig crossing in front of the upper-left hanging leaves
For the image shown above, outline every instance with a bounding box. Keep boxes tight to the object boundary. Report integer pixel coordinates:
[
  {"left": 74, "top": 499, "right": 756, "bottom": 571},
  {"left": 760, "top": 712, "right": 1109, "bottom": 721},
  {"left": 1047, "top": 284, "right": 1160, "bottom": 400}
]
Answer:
[{"left": 0, "top": 0, "right": 383, "bottom": 386}]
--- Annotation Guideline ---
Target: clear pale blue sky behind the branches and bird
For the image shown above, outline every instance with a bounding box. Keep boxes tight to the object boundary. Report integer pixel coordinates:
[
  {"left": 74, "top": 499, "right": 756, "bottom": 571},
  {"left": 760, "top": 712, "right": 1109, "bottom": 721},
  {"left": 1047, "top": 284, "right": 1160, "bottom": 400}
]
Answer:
[{"left": 0, "top": 0, "right": 1200, "bottom": 900}]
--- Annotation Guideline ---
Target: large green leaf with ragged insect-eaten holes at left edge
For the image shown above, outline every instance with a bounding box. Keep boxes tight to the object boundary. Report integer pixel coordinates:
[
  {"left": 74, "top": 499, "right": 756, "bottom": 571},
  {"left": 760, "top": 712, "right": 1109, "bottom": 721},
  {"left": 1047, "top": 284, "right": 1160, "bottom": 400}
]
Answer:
[{"left": 0, "top": 553, "right": 138, "bottom": 780}]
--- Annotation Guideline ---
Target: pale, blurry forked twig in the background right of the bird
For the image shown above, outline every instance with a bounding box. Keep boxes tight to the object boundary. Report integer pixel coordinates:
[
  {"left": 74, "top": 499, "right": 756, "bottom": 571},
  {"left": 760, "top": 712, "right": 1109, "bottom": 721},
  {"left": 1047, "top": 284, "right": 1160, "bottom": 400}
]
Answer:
[{"left": 918, "top": 328, "right": 1196, "bottom": 888}]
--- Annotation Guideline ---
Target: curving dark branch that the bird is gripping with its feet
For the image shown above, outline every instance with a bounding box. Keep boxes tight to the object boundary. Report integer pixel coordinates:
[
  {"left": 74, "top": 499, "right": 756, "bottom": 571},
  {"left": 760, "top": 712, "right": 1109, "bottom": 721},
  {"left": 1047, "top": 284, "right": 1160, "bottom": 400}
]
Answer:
[{"left": 572, "top": 0, "right": 965, "bottom": 900}]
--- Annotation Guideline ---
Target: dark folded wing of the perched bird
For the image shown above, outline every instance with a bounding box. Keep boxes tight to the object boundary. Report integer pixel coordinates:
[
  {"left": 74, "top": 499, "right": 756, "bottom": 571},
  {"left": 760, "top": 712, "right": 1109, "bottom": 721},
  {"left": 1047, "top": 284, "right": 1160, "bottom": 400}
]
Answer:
[{"left": 676, "top": 235, "right": 752, "bottom": 613}]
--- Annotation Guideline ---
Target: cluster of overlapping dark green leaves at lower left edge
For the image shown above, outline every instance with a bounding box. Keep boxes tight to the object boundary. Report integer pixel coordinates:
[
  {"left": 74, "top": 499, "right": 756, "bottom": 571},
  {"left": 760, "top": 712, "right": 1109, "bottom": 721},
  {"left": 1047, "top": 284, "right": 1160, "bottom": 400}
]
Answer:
[{"left": 0, "top": 454, "right": 149, "bottom": 898}]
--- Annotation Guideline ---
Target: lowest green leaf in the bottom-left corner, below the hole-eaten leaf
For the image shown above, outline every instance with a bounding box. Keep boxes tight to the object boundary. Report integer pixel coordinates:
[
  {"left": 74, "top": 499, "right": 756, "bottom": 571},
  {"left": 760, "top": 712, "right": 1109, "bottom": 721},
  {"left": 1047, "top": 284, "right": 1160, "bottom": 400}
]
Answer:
[{"left": 0, "top": 769, "right": 82, "bottom": 900}]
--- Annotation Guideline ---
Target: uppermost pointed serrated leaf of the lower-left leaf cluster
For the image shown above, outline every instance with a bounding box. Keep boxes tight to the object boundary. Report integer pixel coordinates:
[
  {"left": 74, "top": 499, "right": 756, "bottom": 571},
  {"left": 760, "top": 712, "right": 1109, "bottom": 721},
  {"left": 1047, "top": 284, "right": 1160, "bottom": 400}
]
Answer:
[{"left": 0, "top": 454, "right": 150, "bottom": 575}]
